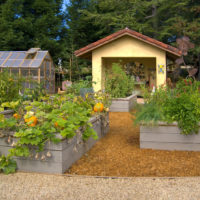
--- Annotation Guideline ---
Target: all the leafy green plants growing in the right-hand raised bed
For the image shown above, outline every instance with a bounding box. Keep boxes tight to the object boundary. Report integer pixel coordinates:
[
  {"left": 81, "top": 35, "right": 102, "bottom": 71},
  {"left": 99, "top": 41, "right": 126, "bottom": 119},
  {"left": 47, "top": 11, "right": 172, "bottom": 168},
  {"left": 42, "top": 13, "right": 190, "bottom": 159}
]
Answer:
[{"left": 135, "top": 80, "right": 200, "bottom": 135}]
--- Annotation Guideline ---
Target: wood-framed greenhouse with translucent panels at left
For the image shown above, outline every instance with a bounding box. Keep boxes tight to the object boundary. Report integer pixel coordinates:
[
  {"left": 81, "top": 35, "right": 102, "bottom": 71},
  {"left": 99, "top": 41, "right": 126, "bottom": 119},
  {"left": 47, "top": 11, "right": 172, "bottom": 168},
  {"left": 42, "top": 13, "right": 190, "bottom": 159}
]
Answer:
[{"left": 0, "top": 48, "right": 55, "bottom": 93}]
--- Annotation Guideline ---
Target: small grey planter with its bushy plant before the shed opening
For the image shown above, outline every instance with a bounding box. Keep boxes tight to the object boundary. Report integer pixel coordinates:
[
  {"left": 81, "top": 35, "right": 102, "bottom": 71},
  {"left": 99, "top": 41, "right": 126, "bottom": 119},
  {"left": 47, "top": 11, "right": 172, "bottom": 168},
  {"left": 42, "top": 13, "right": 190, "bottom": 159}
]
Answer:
[{"left": 105, "top": 63, "right": 137, "bottom": 112}]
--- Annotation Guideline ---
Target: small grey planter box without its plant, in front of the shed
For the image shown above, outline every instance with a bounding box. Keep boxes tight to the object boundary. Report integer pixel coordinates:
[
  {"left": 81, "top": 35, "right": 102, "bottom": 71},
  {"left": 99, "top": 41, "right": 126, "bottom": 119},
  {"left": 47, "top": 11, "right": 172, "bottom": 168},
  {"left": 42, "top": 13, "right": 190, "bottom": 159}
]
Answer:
[{"left": 110, "top": 92, "right": 138, "bottom": 112}]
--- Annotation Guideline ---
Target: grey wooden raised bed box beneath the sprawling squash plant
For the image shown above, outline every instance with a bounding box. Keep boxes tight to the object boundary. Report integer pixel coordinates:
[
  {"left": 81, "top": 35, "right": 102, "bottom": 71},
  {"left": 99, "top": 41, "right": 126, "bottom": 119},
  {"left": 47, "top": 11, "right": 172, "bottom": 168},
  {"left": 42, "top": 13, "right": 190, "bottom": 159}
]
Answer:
[{"left": 0, "top": 116, "right": 109, "bottom": 174}]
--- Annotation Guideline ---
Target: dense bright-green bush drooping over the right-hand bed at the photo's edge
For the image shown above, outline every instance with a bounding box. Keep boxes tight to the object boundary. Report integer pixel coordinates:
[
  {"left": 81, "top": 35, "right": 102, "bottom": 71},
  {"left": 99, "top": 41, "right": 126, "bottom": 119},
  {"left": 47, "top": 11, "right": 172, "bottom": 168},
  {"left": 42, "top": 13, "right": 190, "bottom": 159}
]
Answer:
[{"left": 163, "top": 80, "right": 200, "bottom": 134}]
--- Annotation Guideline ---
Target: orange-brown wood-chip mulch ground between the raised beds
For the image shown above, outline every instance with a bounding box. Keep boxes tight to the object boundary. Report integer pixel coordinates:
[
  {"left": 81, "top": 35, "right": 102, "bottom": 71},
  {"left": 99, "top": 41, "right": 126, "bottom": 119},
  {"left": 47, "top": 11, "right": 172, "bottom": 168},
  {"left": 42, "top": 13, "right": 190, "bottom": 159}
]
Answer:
[{"left": 66, "top": 112, "right": 200, "bottom": 177}]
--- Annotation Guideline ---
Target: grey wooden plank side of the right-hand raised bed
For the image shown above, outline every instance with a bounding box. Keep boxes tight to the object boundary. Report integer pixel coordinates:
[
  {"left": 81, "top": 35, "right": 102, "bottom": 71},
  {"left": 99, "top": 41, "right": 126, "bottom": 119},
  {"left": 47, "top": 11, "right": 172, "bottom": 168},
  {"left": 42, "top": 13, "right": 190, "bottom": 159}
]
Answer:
[{"left": 140, "top": 122, "right": 200, "bottom": 151}]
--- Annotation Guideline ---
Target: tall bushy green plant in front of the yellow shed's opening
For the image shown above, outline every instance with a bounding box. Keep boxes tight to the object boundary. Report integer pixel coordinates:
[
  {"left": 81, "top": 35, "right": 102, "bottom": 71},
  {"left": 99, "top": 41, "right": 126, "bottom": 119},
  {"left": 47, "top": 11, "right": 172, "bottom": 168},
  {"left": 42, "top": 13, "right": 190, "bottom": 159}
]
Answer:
[{"left": 105, "top": 63, "right": 134, "bottom": 98}]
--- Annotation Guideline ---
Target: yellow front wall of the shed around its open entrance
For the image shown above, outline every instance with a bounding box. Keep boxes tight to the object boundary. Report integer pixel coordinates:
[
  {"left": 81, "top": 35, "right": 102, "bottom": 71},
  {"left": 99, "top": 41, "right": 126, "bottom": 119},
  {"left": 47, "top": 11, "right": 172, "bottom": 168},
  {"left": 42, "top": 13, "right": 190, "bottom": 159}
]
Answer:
[{"left": 92, "top": 36, "right": 166, "bottom": 91}]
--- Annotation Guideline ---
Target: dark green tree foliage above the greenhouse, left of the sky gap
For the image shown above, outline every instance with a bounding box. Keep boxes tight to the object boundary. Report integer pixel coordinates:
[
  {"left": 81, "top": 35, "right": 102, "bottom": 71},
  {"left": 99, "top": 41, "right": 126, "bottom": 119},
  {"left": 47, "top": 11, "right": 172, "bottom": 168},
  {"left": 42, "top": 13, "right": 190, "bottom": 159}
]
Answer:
[{"left": 0, "top": 0, "right": 64, "bottom": 63}]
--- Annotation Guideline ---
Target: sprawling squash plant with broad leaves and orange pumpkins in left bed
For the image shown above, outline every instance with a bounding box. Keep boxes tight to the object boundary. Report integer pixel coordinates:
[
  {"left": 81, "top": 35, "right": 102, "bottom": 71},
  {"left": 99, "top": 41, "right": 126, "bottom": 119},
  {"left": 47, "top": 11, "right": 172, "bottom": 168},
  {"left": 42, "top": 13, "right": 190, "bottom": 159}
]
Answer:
[{"left": 0, "top": 93, "right": 108, "bottom": 173}]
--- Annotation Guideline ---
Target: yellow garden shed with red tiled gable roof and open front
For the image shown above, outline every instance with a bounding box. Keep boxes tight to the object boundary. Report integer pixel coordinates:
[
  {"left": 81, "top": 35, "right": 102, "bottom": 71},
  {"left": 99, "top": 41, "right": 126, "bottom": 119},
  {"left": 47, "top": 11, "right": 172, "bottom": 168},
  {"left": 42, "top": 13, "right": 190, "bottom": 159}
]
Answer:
[{"left": 75, "top": 28, "right": 181, "bottom": 91}]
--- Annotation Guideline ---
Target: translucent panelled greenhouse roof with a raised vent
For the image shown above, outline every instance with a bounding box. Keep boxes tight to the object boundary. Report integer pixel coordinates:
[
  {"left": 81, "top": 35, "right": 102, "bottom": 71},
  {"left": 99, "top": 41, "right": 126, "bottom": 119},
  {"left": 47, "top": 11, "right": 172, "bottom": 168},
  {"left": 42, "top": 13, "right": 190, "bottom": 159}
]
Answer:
[{"left": 0, "top": 48, "right": 48, "bottom": 68}]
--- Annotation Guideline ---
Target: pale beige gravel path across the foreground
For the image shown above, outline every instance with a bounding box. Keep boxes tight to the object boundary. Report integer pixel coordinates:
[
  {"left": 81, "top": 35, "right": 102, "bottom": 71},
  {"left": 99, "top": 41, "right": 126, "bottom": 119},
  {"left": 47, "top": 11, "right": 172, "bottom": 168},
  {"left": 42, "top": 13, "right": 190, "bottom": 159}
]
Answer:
[{"left": 0, "top": 172, "right": 200, "bottom": 200}]
